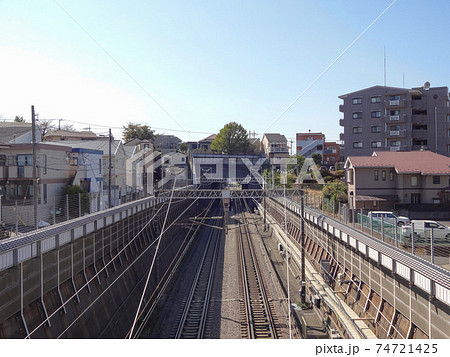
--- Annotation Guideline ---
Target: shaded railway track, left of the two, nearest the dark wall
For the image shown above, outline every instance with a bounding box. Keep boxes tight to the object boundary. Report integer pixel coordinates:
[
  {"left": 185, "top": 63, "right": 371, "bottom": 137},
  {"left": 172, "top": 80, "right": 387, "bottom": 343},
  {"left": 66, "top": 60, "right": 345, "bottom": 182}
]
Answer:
[{"left": 174, "top": 206, "right": 221, "bottom": 339}]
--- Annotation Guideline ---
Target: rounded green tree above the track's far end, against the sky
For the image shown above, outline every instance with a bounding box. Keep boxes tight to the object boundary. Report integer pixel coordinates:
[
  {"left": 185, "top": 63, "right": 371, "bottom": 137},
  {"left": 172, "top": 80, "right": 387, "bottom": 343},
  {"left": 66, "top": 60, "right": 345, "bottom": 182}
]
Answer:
[{"left": 211, "top": 122, "right": 251, "bottom": 154}]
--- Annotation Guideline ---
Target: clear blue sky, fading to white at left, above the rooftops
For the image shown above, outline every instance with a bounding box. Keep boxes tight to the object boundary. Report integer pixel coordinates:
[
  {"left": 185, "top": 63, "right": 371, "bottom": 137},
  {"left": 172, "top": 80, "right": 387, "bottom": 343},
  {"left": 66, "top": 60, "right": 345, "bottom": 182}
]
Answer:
[{"left": 0, "top": 0, "right": 450, "bottom": 145}]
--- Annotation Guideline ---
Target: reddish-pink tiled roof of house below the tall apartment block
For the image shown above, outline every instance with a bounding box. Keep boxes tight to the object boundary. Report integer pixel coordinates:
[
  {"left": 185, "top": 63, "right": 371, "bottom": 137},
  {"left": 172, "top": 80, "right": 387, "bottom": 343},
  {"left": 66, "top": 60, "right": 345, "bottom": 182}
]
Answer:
[{"left": 347, "top": 151, "right": 450, "bottom": 175}]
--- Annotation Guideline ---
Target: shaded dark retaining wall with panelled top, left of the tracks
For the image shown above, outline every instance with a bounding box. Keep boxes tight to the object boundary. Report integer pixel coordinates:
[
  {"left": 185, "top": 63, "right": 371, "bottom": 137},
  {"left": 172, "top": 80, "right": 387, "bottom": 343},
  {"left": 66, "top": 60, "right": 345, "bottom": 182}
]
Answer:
[{"left": 0, "top": 197, "right": 195, "bottom": 338}]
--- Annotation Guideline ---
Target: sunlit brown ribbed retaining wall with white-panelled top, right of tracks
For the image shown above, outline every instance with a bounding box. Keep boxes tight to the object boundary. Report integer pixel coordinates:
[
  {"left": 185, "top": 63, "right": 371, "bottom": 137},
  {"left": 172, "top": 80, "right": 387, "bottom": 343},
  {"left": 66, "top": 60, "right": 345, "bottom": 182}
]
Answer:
[{"left": 267, "top": 199, "right": 450, "bottom": 339}]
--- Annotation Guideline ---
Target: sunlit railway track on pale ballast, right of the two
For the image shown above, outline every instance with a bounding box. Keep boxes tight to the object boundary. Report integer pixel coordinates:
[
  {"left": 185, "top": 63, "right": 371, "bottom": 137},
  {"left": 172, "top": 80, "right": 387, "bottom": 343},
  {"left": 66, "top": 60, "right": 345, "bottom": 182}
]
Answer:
[{"left": 238, "top": 202, "right": 279, "bottom": 339}]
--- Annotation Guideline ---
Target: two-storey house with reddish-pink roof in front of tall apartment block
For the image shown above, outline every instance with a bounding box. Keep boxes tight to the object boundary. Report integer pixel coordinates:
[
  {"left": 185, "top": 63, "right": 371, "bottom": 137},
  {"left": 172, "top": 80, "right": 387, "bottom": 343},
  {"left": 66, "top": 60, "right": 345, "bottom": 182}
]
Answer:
[{"left": 345, "top": 151, "right": 450, "bottom": 214}]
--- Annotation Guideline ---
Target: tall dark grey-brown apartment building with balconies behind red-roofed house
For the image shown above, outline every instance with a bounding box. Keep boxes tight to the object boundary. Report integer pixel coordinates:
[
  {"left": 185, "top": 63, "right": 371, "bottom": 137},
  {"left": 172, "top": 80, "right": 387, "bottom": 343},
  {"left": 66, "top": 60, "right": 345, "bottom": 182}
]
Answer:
[{"left": 339, "top": 82, "right": 450, "bottom": 157}]
